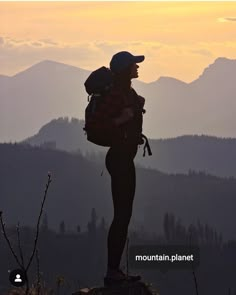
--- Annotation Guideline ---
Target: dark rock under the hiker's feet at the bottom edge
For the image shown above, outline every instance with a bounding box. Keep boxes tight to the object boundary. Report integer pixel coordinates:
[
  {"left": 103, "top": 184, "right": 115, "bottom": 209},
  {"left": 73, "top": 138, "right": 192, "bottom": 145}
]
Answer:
[{"left": 72, "top": 282, "right": 159, "bottom": 295}]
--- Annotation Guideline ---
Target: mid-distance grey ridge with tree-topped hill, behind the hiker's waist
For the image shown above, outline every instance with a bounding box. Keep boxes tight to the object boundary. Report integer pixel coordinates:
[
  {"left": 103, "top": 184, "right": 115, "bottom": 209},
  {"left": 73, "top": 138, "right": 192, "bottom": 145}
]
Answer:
[{"left": 25, "top": 118, "right": 236, "bottom": 177}]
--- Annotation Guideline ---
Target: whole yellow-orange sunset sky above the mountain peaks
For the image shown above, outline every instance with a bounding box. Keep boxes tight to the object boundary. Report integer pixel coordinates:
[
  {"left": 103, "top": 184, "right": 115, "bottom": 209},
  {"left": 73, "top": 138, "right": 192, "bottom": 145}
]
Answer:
[{"left": 0, "top": 2, "right": 236, "bottom": 82}]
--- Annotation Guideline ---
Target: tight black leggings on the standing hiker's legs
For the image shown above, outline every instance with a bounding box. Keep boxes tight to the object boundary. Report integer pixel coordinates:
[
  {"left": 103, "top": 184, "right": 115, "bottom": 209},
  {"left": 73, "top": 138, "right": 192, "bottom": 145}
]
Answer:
[{"left": 106, "top": 146, "right": 137, "bottom": 269}]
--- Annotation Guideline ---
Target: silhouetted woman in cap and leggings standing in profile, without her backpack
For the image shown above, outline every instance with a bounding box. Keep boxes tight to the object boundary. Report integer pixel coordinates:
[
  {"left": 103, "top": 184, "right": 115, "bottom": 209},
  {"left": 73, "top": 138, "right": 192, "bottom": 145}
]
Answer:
[{"left": 104, "top": 51, "right": 145, "bottom": 286}]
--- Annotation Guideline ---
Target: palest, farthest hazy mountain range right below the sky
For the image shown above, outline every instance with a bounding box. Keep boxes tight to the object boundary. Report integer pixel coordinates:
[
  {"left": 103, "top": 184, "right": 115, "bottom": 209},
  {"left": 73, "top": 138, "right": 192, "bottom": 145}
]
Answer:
[{"left": 0, "top": 58, "right": 236, "bottom": 141}]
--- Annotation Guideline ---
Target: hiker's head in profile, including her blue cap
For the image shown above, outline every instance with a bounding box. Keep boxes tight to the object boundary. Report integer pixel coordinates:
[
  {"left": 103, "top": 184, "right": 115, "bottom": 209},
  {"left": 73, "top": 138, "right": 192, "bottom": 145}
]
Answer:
[{"left": 110, "top": 51, "right": 145, "bottom": 81}]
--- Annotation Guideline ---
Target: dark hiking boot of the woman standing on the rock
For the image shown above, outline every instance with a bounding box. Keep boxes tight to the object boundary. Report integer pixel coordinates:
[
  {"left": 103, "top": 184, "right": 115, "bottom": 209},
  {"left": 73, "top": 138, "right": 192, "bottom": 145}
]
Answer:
[{"left": 104, "top": 269, "right": 141, "bottom": 287}]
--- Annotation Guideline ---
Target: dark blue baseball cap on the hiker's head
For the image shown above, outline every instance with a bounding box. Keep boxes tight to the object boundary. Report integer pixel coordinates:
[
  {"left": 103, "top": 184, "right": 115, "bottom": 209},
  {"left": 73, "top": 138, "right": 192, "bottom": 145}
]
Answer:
[{"left": 110, "top": 51, "right": 145, "bottom": 73}]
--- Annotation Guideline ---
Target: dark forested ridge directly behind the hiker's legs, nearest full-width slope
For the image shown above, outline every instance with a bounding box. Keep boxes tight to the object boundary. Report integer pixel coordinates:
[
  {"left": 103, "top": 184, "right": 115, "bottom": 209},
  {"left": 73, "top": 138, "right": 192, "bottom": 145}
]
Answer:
[{"left": 0, "top": 144, "right": 236, "bottom": 239}]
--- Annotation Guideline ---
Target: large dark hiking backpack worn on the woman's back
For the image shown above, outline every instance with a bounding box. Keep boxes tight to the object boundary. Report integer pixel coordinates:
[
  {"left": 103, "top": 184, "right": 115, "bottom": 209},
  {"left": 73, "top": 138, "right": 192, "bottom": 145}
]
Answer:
[{"left": 83, "top": 67, "right": 114, "bottom": 147}]
